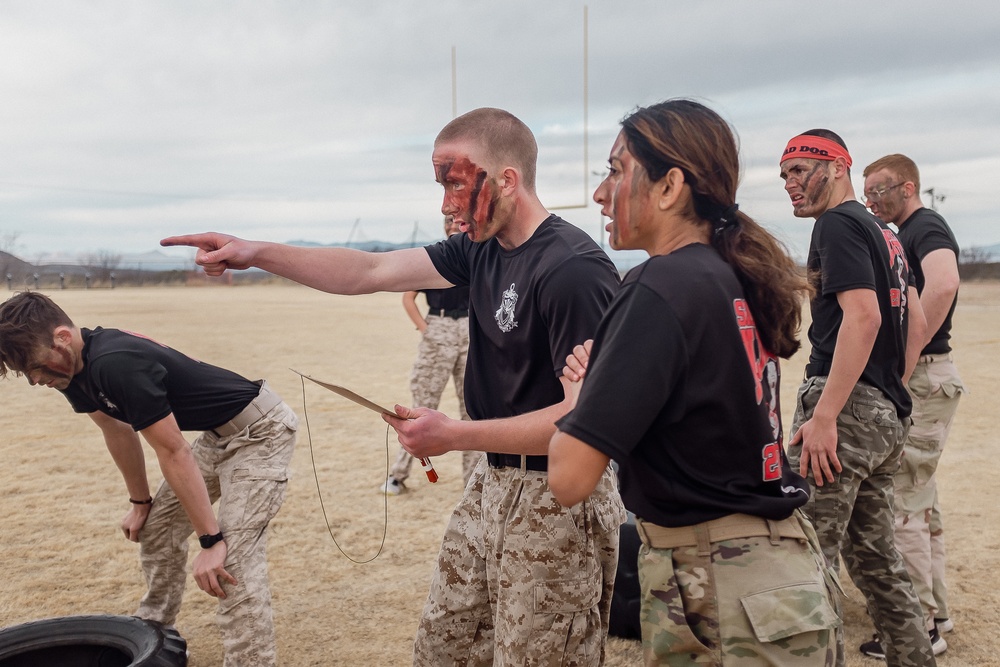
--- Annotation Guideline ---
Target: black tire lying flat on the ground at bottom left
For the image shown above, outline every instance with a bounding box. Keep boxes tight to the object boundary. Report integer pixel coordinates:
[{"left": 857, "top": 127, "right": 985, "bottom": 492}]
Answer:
[{"left": 0, "top": 616, "right": 187, "bottom": 667}]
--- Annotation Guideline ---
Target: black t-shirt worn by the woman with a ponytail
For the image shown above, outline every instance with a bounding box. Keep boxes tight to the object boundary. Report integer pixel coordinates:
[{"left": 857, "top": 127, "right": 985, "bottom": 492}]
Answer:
[{"left": 557, "top": 244, "right": 809, "bottom": 526}]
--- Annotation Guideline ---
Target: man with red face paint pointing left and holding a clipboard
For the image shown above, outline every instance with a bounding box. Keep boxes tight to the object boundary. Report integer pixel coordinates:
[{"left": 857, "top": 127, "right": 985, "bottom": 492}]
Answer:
[{"left": 162, "top": 109, "right": 625, "bottom": 667}]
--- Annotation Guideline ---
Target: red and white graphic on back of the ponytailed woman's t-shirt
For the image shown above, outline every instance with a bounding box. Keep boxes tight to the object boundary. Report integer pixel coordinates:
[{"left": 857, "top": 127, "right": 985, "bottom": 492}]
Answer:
[{"left": 733, "top": 299, "right": 781, "bottom": 482}]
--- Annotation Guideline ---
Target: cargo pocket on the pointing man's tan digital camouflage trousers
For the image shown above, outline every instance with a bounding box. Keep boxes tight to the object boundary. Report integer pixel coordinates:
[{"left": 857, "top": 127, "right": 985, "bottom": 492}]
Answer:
[{"left": 528, "top": 578, "right": 603, "bottom": 665}]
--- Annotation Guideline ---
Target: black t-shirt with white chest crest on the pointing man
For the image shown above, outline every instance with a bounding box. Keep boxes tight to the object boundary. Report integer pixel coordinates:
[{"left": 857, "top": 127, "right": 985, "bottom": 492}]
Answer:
[{"left": 426, "top": 215, "right": 618, "bottom": 419}]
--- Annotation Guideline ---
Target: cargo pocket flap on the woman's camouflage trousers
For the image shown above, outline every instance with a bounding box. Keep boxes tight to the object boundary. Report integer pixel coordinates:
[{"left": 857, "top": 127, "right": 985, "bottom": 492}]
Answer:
[{"left": 740, "top": 582, "right": 840, "bottom": 642}]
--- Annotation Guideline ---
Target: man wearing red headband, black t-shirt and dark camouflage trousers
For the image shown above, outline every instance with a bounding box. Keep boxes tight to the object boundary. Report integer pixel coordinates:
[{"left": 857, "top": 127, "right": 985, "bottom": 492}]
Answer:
[{"left": 781, "top": 130, "right": 935, "bottom": 667}]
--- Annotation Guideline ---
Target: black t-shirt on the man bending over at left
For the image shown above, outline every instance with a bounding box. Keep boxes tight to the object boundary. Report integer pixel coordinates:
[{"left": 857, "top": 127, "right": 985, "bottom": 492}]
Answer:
[{"left": 63, "top": 327, "right": 260, "bottom": 431}]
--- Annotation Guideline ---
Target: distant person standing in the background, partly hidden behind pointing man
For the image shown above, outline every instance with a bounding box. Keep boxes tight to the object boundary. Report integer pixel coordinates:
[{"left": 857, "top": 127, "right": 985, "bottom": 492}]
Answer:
[{"left": 381, "top": 216, "right": 482, "bottom": 496}]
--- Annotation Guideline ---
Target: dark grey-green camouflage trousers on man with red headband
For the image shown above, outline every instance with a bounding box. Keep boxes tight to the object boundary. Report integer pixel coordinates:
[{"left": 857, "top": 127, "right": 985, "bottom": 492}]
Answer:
[{"left": 788, "top": 376, "right": 936, "bottom": 667}]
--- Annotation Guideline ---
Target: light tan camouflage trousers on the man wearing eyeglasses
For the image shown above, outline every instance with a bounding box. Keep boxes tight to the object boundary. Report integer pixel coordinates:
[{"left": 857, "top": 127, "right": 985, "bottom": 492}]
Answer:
[{"left": 894, "top": 354, "right": 965, "bottom": 630}]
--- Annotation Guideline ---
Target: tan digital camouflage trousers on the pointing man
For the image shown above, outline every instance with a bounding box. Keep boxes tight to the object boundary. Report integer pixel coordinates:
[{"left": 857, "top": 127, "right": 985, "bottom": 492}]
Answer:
[{"left": 413, "top": 459, "right": 625, "bottom": 667}]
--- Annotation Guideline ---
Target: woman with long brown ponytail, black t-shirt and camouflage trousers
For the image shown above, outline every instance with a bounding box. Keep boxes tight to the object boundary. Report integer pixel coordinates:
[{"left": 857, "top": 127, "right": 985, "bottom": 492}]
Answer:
[{"left": 549, "top": 99, "right": 840, "bottom": 666}]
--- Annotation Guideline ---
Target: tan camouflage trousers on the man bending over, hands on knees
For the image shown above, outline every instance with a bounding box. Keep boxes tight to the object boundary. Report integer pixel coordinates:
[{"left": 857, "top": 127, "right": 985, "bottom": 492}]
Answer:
[{"left": 136, "top": 403, "right": 298, "bottom": 667}]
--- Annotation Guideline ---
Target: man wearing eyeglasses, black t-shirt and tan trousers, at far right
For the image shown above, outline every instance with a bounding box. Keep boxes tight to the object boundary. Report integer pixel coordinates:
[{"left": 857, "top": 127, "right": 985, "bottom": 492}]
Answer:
[{"left": 862, "top": 154, "right": 965, "bottom": 655}]
